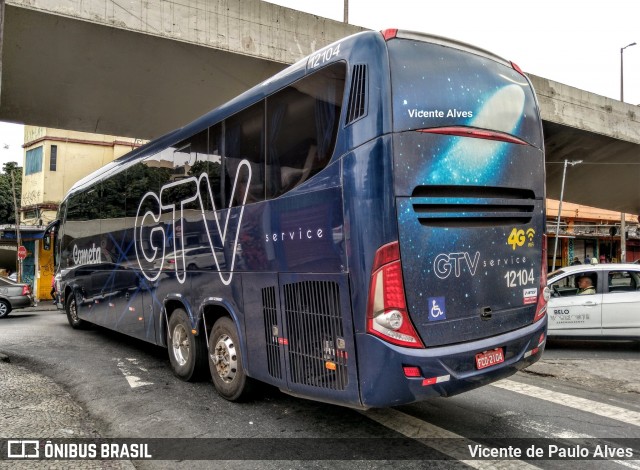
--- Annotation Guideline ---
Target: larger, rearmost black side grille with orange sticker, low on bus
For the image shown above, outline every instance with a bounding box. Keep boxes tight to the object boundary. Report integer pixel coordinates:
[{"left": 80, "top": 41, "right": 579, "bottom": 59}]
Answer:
[{"left": 283, "top": 281, "right": 348, "bottom": 390}]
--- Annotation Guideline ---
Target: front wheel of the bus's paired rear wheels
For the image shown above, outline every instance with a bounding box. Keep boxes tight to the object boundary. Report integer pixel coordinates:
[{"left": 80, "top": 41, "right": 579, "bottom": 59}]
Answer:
[{"left": 167, "top": 308, "right": 207, "bottom": 382}]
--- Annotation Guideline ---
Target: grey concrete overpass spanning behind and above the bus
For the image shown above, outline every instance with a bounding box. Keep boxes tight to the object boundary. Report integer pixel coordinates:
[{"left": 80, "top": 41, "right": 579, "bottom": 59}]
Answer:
[{"left": 0, "top": 0, "right": 640, "bottom": 214}]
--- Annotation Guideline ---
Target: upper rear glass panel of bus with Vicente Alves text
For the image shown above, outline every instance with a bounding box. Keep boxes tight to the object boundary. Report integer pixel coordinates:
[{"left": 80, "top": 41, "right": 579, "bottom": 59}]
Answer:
[{"left": 388, "top": 39, "right": 542, "bottom": 148}]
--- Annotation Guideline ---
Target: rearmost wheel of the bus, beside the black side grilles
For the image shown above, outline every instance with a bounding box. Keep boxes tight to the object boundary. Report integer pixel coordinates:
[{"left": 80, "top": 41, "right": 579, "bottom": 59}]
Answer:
[{"left": 209, "top": 317, "right": 254, "bottom": 401}]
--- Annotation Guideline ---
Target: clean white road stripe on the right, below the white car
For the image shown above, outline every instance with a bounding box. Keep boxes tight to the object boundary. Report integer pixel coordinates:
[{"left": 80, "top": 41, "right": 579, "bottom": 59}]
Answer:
[{"left": 491, "top": 380, "right": 640, "bottom": 426}]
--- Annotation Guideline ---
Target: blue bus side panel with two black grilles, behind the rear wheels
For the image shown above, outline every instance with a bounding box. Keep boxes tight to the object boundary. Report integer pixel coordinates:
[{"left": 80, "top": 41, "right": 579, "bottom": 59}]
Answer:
[{"left": 243, "top": 274, "right": 359, "bottom": 405}]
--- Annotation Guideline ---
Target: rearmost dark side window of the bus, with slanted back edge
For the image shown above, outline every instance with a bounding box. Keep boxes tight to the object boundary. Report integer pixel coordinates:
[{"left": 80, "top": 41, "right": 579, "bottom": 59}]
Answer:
[{"left": 266, "top": 62, "right": 345, "bottom": 198}]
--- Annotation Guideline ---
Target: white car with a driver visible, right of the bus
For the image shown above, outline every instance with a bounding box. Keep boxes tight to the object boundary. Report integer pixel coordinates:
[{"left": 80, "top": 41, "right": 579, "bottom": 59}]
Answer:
[{"left": 547, "top": 263, "right": 640, "bottom": 340}]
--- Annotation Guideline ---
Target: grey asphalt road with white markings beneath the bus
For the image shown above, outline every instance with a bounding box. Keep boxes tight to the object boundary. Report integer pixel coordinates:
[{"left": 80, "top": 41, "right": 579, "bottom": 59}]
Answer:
[{"left": 0, "top": 310, "right": 640, "bottom": 469}]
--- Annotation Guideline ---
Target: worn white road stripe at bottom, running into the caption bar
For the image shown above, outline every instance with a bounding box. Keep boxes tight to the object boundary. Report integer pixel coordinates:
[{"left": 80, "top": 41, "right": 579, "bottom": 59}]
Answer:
[{"left": 361, "top": 408, "right": 538, "bottom": 470}]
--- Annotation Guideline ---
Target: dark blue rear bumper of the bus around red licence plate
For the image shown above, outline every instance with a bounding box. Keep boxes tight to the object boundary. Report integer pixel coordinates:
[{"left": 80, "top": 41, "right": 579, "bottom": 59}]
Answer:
[{"left": 358, "top": 316, "right": 547, "bottom": 408}]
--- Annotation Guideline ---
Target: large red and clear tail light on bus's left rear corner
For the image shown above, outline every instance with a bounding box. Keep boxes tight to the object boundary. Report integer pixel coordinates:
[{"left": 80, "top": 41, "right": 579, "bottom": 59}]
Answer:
[{"left": 367, "top": 242, "right": 424, "bottom": 348}]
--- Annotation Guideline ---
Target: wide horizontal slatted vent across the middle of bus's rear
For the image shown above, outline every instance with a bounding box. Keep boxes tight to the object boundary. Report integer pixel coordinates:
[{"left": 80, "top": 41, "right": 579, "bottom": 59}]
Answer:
[{"left": 411, "top": 186, "right": 535, "bottom": 228}]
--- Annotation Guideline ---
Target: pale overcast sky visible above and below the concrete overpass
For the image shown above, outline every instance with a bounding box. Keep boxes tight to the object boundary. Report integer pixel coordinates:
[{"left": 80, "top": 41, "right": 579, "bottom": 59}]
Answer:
[{"left": 0, "top": 0, "right": 640, "bottom": 170}]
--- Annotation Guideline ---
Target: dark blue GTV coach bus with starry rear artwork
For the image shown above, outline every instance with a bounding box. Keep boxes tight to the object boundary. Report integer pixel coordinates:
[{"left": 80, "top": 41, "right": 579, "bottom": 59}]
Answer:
[{"left": 46, "top": 30, "right": 548, "bottom": 408}]
